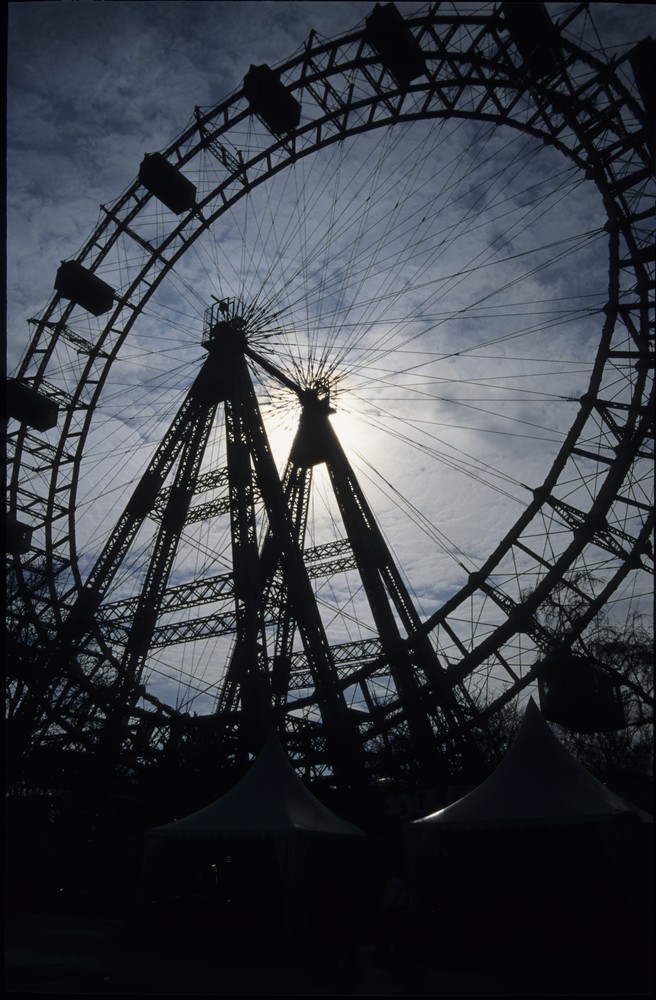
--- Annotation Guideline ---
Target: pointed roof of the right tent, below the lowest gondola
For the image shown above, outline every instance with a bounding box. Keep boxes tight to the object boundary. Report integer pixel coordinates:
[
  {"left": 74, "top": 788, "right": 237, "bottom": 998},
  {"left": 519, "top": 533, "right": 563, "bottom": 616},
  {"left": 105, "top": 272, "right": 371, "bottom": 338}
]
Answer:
[{"left": 410, "top": 699, "right": 651, "bottom": 833}]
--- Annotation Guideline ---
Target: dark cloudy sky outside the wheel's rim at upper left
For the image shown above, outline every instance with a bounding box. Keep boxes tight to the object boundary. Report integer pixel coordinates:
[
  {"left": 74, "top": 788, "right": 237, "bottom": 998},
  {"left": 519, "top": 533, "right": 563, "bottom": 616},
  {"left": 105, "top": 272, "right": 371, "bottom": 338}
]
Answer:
[{"left": 7, "top": 0, "right": 656, "bottom": 370}]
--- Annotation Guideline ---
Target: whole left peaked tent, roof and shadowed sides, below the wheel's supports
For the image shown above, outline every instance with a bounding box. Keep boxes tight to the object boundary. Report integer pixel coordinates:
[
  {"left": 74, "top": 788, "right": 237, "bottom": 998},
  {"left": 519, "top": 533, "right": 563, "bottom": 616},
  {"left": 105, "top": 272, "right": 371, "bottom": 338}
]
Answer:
[{"left": 138, "top": 732, "right": 367, "bottom": 934}]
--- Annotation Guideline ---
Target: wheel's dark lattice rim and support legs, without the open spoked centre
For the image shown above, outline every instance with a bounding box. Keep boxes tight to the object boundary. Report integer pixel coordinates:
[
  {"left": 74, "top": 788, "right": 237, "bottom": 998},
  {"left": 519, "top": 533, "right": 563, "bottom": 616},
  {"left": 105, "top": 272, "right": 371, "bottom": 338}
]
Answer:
[{"left": 7, "top": 3, "right": 654, "bottom": 820}]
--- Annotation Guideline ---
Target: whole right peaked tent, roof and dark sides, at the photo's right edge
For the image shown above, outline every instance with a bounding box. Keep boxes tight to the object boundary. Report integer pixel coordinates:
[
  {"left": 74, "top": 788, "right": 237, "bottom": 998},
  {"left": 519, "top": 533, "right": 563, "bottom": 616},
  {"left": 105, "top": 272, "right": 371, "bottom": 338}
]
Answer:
[{"left": 406, "top": 701, "right": 652, "bottom": 953}]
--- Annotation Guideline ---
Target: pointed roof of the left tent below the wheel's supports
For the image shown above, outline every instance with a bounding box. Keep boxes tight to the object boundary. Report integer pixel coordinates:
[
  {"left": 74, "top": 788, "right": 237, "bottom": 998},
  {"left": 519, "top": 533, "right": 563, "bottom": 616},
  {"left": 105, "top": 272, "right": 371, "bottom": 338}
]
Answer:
[{"left": 151, "top": 731, "right": 364, "bottom": 837}]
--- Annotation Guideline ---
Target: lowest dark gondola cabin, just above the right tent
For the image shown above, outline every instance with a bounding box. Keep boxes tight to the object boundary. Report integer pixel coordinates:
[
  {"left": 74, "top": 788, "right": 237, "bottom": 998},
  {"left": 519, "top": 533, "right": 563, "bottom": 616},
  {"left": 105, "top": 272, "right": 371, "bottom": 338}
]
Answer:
[{"left": 538, "top": 651, "right": 626, "bottom": 733}]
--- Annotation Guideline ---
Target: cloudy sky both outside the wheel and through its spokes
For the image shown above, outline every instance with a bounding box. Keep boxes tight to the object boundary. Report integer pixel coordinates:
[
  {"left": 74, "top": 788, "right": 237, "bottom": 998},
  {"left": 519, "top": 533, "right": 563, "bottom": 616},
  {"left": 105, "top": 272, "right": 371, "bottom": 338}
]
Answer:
[{"left": 7, "top": 0, "right": 656, "bottom": 720}]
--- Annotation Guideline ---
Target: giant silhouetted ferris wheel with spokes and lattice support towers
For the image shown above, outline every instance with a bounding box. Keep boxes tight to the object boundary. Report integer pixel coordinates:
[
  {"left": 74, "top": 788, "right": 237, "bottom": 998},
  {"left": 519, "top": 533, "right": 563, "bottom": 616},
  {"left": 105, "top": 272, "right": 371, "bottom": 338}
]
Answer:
[{"left": 7, "top": 4, "right": 655, "bottom": 786}]
